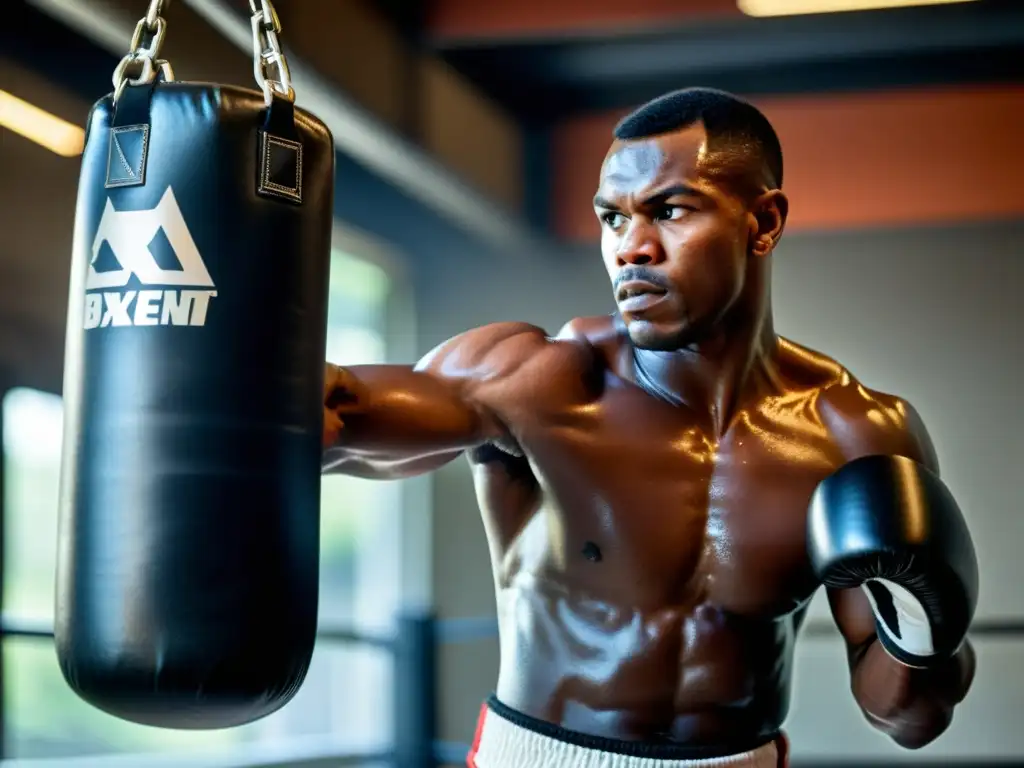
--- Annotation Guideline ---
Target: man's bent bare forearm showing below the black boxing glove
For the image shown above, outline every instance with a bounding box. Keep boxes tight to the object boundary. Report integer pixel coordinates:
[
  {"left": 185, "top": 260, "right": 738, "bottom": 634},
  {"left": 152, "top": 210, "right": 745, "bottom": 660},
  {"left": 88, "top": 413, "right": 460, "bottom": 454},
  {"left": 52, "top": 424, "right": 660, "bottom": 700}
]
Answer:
[{"left": 852, "top": 640, "right": 975, "bottom": 749}]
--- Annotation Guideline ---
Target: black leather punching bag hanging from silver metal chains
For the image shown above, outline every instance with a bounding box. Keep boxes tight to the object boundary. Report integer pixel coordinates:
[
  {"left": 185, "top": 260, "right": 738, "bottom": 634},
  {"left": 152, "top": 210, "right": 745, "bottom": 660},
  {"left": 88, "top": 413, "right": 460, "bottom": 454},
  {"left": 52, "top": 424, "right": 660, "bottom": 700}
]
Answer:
[{"left": 56, "top": 0, "right": 334, "bottom": 728}]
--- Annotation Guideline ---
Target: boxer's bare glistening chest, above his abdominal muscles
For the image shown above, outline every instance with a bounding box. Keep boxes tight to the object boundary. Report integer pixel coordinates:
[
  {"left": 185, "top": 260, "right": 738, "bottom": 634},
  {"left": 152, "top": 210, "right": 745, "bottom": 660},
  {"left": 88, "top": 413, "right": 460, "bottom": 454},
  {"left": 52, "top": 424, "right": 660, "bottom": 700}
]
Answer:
[{"left": 493, "top": 381, "right": 838, "bottom": 617}]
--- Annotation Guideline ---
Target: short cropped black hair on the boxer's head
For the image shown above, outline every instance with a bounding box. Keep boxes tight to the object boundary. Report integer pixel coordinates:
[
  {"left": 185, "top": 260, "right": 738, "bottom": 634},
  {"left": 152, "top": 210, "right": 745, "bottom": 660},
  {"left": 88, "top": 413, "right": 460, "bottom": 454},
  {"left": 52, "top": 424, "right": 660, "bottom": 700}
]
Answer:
[{"left": 614, "top": 88, "right": 782, "bottom": 188}]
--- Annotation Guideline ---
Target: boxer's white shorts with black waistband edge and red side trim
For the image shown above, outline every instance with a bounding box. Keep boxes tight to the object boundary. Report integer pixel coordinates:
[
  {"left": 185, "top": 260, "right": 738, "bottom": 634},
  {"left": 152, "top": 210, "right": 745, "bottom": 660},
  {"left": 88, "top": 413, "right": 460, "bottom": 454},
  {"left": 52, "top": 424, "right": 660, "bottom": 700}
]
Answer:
[{"left": 466, "top": 696, "right": 788, "bottom": 768}]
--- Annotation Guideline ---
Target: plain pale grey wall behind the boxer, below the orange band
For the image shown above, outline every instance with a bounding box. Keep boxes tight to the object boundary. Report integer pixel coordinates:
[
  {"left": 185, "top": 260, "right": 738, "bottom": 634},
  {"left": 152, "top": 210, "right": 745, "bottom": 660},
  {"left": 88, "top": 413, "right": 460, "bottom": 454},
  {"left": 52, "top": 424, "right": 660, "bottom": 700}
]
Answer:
[{"left": 419, "top": 222, "right": 1024, "bottom": 761}]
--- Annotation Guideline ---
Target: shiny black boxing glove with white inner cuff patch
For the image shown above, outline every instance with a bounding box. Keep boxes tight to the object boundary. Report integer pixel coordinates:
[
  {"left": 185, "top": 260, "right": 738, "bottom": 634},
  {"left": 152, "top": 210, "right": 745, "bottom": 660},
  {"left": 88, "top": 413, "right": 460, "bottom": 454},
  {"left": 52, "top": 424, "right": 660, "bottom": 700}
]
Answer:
[{"left": 808, "top": 456, "right": 978, "bottom": 668}]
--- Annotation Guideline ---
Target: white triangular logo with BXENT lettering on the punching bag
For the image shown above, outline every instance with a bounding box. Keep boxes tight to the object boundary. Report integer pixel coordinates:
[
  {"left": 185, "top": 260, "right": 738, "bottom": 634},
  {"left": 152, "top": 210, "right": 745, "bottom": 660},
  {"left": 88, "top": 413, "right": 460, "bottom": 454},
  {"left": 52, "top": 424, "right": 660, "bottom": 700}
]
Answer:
[{"left": 85, "top": 187, "right": 217, "bottom": 330}]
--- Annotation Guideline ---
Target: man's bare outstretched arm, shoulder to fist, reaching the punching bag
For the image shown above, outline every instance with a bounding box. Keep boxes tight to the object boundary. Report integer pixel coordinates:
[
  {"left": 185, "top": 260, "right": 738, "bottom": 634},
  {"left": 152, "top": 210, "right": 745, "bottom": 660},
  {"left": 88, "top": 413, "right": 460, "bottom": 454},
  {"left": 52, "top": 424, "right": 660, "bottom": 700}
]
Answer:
[{"left": 323, "top": 323, "right": 550, "bottom": 478}]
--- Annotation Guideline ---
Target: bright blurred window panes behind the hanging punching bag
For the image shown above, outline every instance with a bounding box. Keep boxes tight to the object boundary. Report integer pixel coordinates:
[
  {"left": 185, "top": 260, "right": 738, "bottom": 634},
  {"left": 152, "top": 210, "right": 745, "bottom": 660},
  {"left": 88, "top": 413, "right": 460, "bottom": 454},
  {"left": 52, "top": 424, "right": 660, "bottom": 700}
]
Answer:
[{"left": 2, "top": 246, "right": 411, "bottom": 759}]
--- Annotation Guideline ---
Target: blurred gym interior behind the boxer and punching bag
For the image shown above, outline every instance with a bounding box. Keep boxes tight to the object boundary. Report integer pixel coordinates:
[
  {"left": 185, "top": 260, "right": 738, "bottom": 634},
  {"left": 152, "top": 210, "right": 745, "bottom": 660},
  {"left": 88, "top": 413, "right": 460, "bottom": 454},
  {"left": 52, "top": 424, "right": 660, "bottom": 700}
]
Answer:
[{"left": 0, "top": 0, "right": 1024, "bottom": 768}]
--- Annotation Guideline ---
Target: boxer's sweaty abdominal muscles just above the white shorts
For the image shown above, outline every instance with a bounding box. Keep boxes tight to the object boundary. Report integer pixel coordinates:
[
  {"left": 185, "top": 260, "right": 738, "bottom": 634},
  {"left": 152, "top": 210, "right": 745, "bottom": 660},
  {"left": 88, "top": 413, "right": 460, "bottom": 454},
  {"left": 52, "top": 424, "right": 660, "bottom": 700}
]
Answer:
[{"left": 496, "top": 573, "right": 788, "bottom": 745}]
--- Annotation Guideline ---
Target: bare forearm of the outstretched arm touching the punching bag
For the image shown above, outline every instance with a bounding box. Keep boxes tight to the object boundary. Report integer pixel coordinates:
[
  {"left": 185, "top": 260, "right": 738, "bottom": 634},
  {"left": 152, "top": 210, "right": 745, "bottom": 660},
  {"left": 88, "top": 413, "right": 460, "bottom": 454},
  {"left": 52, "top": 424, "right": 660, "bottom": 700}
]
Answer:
[{"left": 324, "top": 366, "right": 486, "bottom": 476}]
